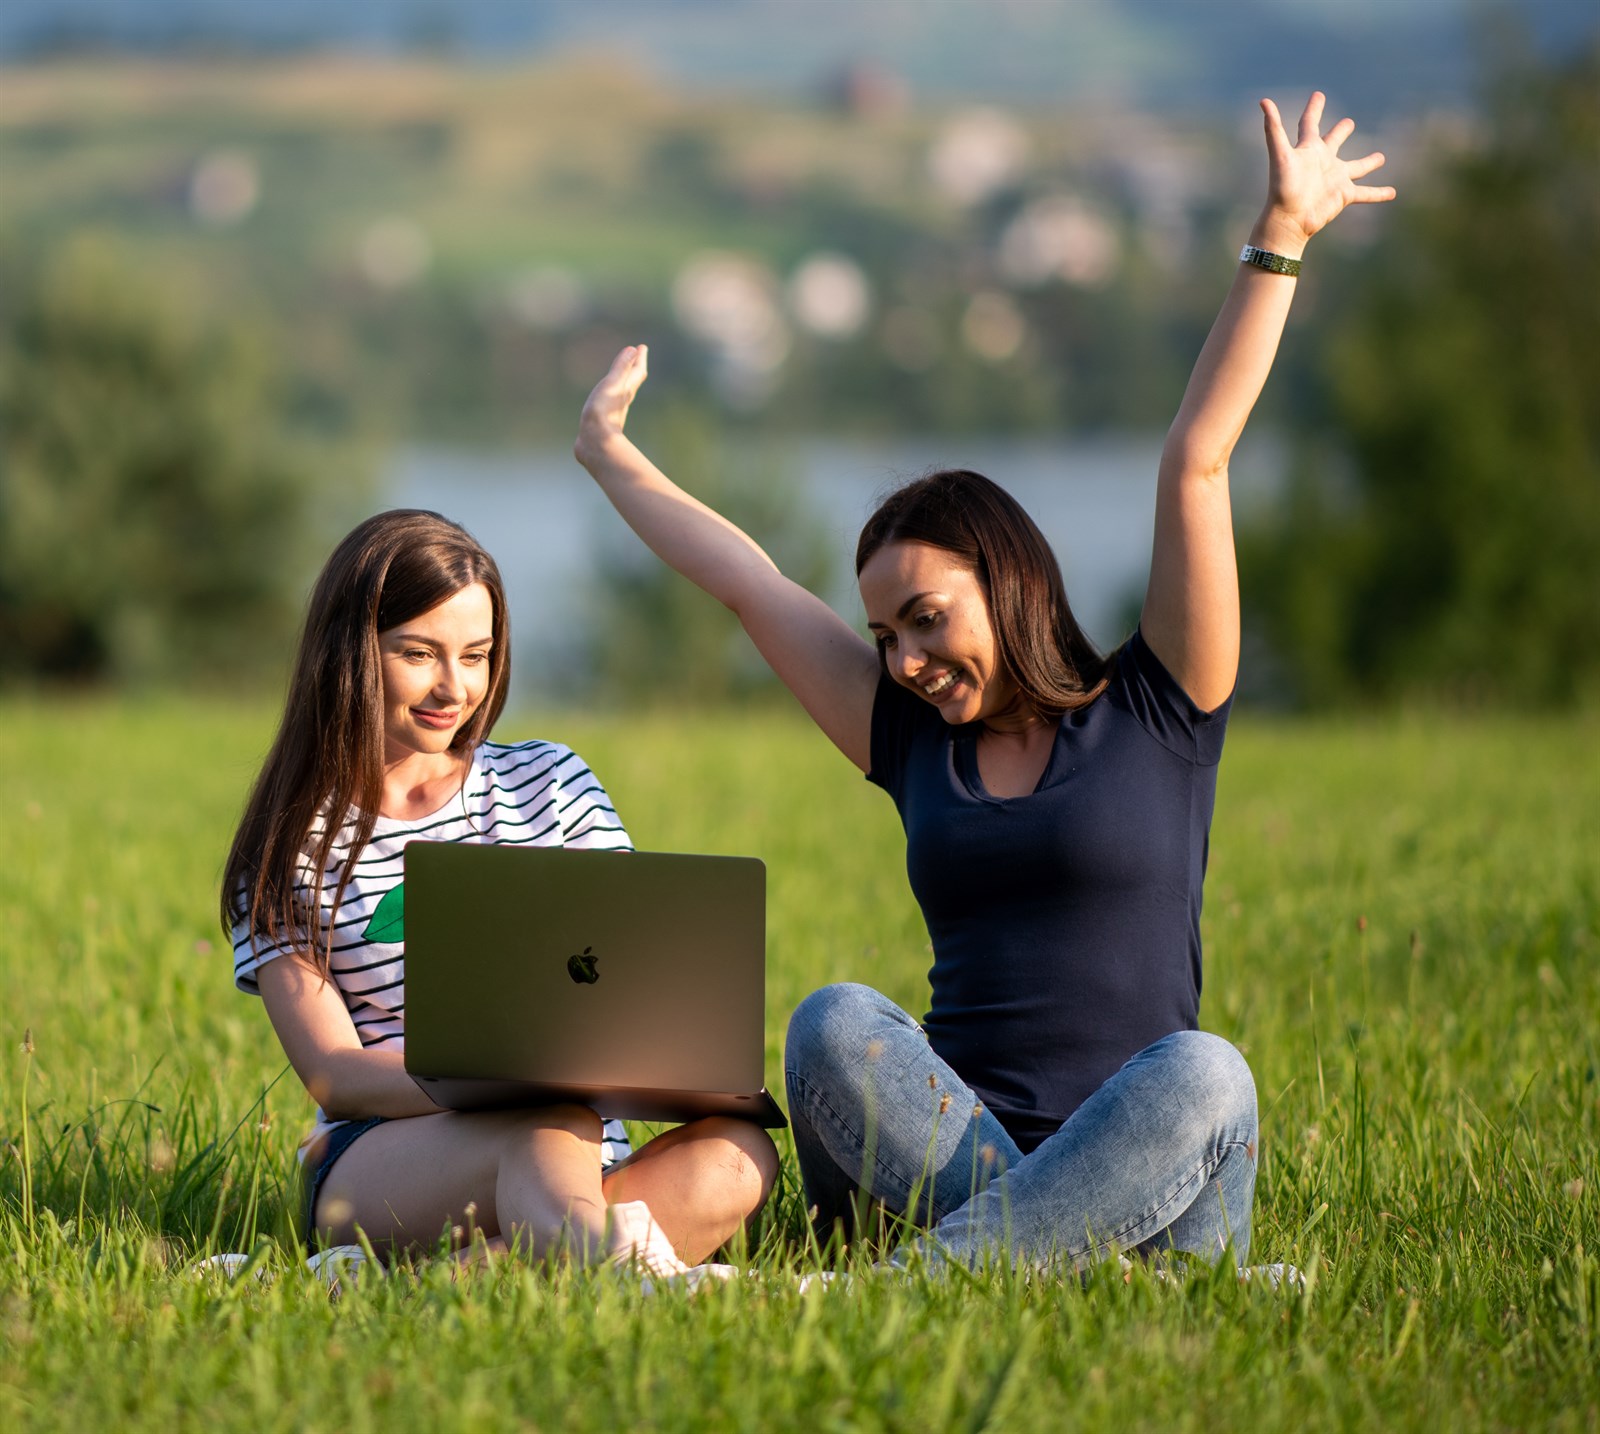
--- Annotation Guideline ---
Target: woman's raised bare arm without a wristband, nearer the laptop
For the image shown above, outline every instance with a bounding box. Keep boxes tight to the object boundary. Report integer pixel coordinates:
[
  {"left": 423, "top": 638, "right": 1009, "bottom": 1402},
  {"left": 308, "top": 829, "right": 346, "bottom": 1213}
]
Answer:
[{"left": 573, "top": 344, "right": 878, "bottom": 771}]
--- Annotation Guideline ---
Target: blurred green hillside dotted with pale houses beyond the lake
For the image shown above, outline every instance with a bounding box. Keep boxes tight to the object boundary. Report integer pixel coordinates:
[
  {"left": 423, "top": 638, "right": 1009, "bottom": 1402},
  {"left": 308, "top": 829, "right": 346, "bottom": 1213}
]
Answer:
[{"left": 0, "top": 56, "right": 1248, "bottom": 445}]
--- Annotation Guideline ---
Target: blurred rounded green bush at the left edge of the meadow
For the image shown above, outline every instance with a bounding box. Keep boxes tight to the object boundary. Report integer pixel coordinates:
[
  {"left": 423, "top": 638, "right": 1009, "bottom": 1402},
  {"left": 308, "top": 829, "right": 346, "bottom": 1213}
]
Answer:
[{"left": 0, "top": 237, "right": 348, "bottom": 680}]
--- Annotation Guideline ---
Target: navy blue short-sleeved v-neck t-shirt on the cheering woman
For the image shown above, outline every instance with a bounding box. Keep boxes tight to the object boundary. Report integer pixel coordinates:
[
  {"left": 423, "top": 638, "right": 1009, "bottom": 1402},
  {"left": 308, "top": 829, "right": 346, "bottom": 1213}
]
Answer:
[{"left": 867, "top": 632, "right": 1232, "bottom": 1151}]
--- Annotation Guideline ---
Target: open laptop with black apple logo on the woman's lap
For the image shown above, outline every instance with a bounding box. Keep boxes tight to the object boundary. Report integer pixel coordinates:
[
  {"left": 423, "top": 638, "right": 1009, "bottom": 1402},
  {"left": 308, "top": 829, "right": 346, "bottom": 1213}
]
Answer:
[{"left": 405, "top": 842, "right": 787, "bottom": 1125}]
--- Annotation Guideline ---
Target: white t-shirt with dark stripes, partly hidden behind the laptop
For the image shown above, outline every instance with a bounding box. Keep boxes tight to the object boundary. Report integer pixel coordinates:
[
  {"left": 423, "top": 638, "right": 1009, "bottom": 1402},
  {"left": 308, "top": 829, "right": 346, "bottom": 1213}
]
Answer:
[{"left": 234, "top": 741, "right": 632, "bottom": 1164}]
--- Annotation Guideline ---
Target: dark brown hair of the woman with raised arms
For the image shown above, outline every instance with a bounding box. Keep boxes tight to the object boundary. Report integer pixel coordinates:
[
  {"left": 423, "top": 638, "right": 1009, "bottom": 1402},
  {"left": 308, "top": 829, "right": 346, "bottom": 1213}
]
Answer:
[{"left": 856, "top": 467, "right": 1112, "bottom": 717}]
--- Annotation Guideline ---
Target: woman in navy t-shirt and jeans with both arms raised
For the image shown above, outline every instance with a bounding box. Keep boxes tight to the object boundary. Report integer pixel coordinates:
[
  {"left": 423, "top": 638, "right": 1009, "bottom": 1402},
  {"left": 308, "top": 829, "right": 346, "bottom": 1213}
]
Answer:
[{"left": 576, "top": 94, "right": 1394, "bottom": 1266}]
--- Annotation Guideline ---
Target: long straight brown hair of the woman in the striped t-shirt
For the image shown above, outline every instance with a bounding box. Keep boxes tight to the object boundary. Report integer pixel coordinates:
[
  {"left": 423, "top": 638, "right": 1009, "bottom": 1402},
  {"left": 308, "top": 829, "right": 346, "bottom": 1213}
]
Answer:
[{"left": 222, "top": 507, "right": 510, "bottom": 975}]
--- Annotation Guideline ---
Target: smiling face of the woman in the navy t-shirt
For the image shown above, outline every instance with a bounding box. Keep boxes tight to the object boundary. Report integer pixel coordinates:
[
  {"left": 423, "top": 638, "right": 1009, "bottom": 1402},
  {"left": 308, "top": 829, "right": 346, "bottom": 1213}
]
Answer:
[{"left": 861, "top": 543, "right": 1034, "bottom": 728}]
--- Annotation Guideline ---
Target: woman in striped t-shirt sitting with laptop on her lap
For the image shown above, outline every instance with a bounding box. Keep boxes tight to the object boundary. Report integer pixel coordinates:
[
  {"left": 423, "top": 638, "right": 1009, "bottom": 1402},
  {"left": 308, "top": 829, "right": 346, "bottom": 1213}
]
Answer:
[{"left": 222, "top": 509, "right": 776, "bottom": 1276}]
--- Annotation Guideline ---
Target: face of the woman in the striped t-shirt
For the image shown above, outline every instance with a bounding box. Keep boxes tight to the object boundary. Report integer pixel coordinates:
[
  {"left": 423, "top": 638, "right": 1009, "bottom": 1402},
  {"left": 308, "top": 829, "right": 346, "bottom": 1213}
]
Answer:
[{"left": 378, "top": 583, "right": 494, "bottom": 765}]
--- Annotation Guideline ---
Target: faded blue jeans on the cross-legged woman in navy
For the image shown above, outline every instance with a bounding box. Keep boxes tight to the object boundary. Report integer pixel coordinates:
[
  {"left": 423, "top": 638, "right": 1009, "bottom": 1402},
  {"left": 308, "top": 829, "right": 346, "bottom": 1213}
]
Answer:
[{"left": 784, "top": 984, "right": 1256, "bottom": 1269}]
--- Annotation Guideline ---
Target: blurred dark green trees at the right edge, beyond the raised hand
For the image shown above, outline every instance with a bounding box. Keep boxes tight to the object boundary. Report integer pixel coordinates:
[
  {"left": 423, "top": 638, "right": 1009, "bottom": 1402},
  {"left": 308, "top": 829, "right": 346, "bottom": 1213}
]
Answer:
[{"left": 1242, "top": 33, "right": 1600, "bottom": 704}]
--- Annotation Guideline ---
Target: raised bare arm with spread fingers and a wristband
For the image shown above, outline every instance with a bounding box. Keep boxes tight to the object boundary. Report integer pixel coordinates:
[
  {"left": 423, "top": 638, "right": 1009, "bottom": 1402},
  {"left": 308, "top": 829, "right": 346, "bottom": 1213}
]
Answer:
[{"left": 1139, "top": 91, "right": 1395, "bottom": 711}]
